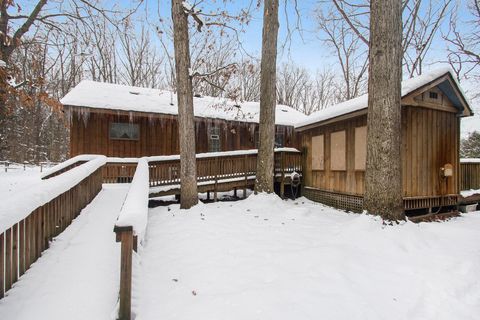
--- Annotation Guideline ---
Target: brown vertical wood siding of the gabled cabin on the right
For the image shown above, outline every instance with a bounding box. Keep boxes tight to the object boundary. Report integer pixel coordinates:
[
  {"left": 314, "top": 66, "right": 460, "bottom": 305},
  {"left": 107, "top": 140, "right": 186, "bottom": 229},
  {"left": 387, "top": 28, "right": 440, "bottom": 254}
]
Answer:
[{"left": 302, "top": 106, "right": 460, "bottom": 197}]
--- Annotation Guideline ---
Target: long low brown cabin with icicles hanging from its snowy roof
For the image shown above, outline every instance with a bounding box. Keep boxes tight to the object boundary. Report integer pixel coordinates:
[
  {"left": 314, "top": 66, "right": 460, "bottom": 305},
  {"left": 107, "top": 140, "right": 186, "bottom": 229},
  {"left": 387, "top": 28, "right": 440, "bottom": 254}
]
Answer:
[{"left": 61, "top": 81, "right": 306, "bottom": 157}]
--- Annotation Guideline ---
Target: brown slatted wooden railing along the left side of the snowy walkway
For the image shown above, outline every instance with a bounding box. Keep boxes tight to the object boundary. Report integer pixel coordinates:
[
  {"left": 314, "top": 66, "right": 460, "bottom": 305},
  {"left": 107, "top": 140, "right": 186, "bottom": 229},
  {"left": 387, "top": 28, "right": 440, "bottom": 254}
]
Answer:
[{"left": 0, "top": 158, "right": 102, "bottom": 298}]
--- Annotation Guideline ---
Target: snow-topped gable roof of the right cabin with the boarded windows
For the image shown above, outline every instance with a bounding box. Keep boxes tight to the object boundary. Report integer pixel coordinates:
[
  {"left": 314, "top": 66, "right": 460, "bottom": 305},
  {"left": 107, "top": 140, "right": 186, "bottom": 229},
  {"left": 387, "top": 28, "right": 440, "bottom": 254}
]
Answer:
[{"left": 295, "top": 68, "right": 473, "bottom": 130}]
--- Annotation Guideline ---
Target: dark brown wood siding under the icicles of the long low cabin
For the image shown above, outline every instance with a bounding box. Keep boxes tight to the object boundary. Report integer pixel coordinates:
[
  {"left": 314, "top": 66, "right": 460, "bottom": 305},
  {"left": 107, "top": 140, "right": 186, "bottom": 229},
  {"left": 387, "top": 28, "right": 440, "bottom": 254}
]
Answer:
[{"left": 70, "top": 111, "right": 300, "bottom": 157}]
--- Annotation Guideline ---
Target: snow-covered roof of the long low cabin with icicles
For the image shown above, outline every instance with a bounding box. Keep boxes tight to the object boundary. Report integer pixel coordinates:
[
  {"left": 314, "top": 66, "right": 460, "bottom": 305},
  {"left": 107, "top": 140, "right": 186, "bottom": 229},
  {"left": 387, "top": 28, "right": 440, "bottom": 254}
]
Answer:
[{"left": 60, "top": 80, "right": 306, "bottom": 126}]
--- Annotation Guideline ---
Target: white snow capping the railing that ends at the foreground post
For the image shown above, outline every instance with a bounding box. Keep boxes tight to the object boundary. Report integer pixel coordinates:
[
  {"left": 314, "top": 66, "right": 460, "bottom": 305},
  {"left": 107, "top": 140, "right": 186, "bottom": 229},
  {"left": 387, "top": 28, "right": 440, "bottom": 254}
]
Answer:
[{"left": 115, "top": 158, "right": 150, "bottom": 242}]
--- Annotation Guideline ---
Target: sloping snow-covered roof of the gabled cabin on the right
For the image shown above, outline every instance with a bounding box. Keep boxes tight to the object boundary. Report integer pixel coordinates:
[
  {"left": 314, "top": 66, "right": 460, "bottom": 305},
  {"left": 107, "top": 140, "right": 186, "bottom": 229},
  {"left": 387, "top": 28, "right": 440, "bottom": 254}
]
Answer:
[{"left": 295, "top": 67, "right": 468, "bottom": 128}]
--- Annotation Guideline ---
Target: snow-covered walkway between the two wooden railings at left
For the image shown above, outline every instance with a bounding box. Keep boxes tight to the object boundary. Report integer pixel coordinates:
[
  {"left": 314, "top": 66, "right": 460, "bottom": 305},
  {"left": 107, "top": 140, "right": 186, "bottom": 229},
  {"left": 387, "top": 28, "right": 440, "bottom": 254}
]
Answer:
[{"left": 0, "top": 185, "right": 128, "bottom": 320}]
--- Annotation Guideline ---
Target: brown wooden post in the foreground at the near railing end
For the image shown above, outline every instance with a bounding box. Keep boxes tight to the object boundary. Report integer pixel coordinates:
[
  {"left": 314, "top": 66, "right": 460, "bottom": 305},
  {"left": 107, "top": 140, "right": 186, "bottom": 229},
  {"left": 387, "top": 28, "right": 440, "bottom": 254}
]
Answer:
[{"left": 114, "top": 226, "right": 133, "bottom": 320}]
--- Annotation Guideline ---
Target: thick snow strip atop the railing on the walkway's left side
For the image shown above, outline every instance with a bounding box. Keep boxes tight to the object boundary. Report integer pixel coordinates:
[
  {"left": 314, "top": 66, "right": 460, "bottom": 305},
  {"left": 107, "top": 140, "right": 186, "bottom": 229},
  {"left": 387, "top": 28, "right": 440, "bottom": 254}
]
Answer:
[{"left": 0, "top": 155, "right": 107, "bottom": 234}]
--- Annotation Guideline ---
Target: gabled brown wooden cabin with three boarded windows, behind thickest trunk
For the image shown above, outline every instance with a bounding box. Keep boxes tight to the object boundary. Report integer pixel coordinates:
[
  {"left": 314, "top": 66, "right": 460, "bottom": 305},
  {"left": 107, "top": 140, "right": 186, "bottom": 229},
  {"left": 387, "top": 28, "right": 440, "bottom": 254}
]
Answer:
[{"left": 296, "top": 69, "right": 472, "bottom": 214}]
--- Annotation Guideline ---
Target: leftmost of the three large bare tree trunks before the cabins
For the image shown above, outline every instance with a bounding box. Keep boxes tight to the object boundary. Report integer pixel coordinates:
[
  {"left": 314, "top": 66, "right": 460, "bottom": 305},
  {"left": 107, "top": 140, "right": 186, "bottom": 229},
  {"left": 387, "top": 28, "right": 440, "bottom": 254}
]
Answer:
[{"left": 172, "top": 0, "right": 198, "bottom": 209}]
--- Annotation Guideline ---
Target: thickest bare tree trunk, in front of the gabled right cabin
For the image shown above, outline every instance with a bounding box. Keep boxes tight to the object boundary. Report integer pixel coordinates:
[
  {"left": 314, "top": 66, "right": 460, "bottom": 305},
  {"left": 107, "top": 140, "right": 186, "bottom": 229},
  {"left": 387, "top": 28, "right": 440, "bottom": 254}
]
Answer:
[{"left": 365, "top": 0, "right": 405, "bottom": 220}]
